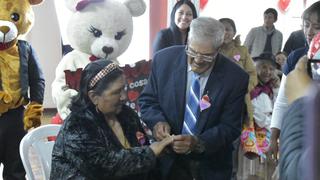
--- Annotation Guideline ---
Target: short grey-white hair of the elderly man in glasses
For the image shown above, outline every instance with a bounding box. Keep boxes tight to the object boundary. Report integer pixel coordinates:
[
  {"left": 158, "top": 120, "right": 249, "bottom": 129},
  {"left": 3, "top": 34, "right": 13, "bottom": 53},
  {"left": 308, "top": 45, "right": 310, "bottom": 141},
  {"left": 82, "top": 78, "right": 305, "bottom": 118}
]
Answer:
[{"left": 188, "top": 17, "right": 225, "bottom": 49}]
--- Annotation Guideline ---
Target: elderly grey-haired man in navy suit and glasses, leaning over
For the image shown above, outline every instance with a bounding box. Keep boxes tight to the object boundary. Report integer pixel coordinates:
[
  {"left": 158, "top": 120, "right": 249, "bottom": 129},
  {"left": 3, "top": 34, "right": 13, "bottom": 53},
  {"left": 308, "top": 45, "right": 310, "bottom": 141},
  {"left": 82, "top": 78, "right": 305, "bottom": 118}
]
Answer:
[{"left": 139, "top": 17, "right": 249, "bottom": 180}]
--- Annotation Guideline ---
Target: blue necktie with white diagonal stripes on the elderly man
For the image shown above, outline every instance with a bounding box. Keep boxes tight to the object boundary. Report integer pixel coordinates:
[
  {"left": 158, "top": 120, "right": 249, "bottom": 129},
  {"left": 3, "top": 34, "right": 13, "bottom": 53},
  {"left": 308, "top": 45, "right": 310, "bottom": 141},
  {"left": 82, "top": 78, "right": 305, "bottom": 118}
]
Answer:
[{"left": 182, "top": 74, "right": 200, "bottom": 135}]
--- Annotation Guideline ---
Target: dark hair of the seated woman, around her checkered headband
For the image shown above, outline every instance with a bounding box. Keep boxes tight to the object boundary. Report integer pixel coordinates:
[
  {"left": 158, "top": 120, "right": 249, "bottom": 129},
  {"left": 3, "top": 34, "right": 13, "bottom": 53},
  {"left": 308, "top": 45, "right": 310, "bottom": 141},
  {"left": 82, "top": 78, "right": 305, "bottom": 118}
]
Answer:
[{"left": 70, "top": 60, "right": 123, "bottom": 111}]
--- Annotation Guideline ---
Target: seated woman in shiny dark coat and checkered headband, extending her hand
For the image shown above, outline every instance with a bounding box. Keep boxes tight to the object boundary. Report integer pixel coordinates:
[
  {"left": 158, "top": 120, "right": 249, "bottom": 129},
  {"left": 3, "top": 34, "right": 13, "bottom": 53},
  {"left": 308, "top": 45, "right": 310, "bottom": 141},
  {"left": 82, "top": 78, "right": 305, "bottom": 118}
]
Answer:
[{"left": 50, "top": 60, "right": 173, "bottom": 180}]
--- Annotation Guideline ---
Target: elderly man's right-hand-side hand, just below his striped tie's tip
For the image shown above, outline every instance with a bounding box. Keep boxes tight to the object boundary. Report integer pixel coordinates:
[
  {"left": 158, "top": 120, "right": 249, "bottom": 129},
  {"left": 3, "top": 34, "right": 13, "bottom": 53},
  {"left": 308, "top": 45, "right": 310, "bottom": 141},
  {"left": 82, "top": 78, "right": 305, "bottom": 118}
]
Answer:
[{"left": 172, "top": 135, "right": 198, "bottom": 154}]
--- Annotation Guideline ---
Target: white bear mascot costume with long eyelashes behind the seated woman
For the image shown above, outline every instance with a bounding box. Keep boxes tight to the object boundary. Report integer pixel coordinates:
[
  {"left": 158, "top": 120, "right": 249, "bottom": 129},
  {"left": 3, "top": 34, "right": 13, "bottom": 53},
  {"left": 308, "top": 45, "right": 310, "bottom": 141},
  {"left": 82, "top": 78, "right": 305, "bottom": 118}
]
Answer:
[{"left": 52, "top": 0, "right": 146, "bottom": 124}]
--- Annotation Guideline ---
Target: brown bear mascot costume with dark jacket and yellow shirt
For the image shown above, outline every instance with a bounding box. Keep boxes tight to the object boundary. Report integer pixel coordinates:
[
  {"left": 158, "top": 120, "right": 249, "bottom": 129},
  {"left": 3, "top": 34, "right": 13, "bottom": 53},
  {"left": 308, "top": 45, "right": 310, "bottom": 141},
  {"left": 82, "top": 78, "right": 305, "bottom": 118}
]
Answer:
[{"left": 0, "top": 0, "right": 45, "bottom": 180}]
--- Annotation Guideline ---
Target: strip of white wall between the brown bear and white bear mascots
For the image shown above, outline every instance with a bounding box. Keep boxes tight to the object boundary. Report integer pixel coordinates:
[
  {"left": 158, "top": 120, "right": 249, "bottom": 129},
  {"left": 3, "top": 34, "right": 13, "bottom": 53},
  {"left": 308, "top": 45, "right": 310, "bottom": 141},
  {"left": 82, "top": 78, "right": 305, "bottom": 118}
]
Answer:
[{"left": 27, "top": 0, "right": 61, "bottom": 108}]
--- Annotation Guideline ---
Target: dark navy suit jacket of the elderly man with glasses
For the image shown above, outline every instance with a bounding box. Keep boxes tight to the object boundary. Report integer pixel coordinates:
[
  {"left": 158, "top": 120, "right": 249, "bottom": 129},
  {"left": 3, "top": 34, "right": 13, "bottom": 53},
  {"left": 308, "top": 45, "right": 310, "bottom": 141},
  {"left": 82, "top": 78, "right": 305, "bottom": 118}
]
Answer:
[{"left": 139, "top": 46, "right": 249, "bottom": 180}]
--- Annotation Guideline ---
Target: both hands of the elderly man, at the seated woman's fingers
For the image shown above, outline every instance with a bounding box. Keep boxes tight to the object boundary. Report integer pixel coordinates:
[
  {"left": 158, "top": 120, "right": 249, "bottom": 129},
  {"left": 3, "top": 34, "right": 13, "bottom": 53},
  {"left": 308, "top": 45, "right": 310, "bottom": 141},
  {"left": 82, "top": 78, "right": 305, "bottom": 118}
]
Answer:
[{"left": 153, "top": 122, "right": 198, "bottom": 154}]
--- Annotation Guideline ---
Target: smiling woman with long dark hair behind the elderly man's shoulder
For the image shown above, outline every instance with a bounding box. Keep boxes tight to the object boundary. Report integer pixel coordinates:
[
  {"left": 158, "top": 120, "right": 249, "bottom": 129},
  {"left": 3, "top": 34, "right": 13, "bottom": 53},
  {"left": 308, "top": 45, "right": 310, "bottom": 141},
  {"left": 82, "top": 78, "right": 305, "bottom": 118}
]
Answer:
[{"left": 153, "top": 0, "right": 197, "bottom": 54}]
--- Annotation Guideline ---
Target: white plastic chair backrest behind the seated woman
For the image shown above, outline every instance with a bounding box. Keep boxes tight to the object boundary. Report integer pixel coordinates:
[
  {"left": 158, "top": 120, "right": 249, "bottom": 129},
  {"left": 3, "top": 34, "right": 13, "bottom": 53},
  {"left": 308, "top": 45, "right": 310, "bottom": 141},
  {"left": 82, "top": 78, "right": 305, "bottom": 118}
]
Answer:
[{"left": 20, "top": 124, "right": 61, "bottom": 180}]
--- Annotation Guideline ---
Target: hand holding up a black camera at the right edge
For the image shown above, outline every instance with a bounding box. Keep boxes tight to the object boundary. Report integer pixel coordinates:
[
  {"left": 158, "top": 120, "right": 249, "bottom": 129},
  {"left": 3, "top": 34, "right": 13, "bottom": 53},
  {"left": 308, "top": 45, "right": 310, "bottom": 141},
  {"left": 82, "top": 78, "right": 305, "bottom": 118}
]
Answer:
[{"left": 285, "top": 56, "right": 312, "bottom": 104}]
